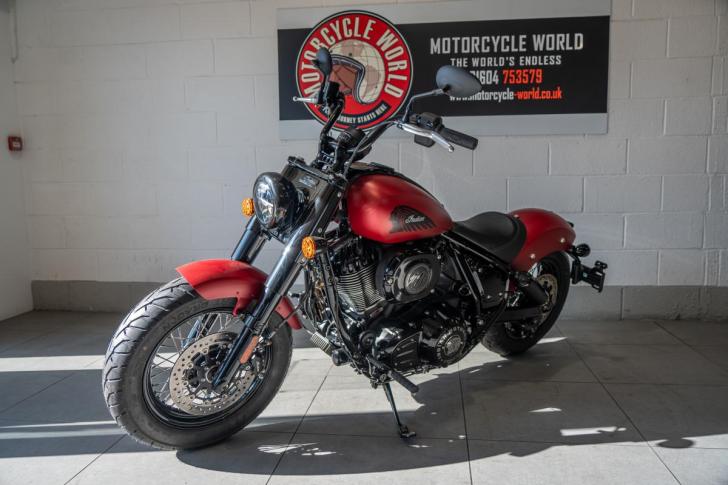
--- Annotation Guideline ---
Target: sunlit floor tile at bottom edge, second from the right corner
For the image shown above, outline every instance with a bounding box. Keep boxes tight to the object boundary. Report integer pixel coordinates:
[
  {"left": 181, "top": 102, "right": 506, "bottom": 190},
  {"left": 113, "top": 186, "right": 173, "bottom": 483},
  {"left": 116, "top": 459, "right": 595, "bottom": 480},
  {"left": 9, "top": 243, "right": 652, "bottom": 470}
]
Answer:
[{"left": 469, "top": 440, "right": 677, "bottom": 485}]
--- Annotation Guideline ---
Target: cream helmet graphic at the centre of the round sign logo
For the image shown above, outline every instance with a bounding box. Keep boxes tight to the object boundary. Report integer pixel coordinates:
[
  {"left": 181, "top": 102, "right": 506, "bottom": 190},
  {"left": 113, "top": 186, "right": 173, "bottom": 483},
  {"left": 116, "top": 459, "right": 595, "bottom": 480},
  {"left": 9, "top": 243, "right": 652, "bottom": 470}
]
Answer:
[{"left": 331, "top": 39, "right": 384, "bottom": 104}]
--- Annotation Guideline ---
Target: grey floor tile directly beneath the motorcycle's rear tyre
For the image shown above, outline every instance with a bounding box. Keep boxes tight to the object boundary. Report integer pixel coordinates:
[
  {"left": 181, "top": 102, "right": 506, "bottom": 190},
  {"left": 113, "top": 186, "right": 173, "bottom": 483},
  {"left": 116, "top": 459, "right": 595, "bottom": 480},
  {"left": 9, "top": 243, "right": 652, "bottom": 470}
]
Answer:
[{"left": 459, "top": 340, "right": 596, "bottom": 382}]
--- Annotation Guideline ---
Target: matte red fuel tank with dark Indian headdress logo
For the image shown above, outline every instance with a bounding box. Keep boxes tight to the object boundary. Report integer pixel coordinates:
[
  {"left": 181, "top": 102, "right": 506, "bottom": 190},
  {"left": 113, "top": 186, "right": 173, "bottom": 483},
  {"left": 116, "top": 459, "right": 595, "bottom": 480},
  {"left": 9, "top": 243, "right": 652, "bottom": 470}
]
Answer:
[{"left": 346, "top": 174, "right": 452, "bottom": 244}]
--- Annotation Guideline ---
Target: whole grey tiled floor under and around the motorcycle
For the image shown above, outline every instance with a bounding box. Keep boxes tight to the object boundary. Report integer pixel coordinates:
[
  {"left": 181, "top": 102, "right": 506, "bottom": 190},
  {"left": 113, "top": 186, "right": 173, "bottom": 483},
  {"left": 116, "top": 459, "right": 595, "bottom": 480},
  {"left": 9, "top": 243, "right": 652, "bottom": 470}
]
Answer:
[{"left": 0, "top": 312, "right": 728, "bottom": 485}]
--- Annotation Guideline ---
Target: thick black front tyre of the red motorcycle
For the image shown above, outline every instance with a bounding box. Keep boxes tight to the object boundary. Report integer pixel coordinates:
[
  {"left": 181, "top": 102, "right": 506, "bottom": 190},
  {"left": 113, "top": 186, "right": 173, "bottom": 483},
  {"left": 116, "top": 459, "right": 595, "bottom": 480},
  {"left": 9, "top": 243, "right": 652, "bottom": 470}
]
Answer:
[{"left": 102, "top": 278, "right": 293, "bottom": 449}]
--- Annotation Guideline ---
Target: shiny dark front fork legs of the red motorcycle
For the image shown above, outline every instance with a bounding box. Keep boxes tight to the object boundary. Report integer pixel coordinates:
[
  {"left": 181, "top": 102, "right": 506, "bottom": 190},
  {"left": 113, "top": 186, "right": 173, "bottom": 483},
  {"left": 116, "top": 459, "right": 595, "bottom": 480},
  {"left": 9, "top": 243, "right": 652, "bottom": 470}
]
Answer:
[{"left": 212, "top": 180, "right": 343, "bottom": 388}]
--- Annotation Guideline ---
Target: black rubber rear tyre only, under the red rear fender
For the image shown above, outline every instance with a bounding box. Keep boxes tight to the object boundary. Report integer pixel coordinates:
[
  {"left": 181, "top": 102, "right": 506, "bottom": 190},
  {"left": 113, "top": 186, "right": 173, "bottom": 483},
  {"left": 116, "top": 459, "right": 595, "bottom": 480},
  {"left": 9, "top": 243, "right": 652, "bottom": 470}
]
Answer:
[{"left": 482, "top": 252, "right": 571, "bottom": 357}]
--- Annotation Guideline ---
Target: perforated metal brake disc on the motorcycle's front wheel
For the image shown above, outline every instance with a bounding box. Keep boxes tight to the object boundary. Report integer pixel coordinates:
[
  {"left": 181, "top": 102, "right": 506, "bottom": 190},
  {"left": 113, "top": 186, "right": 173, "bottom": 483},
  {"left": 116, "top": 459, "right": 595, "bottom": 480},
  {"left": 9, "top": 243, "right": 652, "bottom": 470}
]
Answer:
[{"left": 169, "top": 332, "right": 255, "bottom": 416}]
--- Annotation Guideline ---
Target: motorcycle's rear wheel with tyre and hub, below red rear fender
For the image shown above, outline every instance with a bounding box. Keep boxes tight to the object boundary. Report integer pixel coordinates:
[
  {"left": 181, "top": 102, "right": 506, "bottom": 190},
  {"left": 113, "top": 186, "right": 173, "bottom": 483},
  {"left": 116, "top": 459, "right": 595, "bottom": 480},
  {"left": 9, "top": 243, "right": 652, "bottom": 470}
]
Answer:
[{"left": 482, "top": 252, "right": 571, "bottom": 356}]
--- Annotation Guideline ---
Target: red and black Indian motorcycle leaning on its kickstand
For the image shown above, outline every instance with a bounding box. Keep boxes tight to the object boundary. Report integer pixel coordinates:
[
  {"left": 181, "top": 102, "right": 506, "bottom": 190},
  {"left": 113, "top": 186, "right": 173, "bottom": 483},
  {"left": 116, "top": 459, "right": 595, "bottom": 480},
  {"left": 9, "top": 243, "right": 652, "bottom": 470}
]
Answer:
[{"left": 103, "top": 49, "right": 606, "bottom": 448}]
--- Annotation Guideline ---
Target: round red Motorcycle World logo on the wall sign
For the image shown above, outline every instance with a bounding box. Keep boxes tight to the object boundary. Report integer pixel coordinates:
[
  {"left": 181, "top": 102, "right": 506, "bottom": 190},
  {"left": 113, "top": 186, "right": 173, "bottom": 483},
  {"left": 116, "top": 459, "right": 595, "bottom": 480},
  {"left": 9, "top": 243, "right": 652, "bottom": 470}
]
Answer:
[{"left": 296, "top": 11, "right": 412, "bottom": 129}]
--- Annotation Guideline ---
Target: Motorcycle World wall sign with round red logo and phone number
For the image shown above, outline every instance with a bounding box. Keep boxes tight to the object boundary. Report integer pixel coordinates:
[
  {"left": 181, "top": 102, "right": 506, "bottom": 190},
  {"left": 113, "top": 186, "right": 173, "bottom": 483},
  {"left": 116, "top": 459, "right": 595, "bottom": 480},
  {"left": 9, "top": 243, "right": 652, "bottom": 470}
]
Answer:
[{"left": 278, "top": 0, "right": 611, "bottom": 138}]
